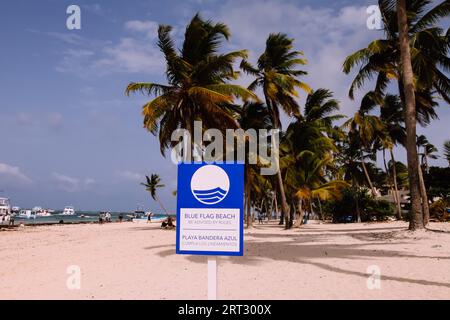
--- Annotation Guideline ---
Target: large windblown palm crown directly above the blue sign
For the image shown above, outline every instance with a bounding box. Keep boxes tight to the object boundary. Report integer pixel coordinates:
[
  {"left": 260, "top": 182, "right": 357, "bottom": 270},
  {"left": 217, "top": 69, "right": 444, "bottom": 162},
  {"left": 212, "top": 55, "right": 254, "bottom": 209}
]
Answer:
[{"left": 126, "top": 14, "right": 257, "bottom": 154}]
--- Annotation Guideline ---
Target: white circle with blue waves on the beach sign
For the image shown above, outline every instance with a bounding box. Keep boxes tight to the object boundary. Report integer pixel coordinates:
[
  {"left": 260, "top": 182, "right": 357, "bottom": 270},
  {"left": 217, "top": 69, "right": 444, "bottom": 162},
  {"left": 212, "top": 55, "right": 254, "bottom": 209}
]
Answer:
[{"left": 191, "top": 165, "right": 230, "bottom": 205}]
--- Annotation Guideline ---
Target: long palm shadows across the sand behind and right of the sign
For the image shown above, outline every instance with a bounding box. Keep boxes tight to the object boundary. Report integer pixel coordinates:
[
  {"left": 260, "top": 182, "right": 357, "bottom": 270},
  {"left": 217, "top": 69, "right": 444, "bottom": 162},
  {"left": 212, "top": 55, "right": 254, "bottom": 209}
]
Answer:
[{"left": 146, "top": 228, "right": 450, "bottom": 288}]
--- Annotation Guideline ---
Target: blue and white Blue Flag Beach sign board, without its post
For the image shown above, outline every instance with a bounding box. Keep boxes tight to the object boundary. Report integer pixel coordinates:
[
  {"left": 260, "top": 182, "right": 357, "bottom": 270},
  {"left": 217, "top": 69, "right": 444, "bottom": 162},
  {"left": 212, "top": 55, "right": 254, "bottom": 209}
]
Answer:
[{"left": 176, "top": 163, "right": 244, "bottom": 256}]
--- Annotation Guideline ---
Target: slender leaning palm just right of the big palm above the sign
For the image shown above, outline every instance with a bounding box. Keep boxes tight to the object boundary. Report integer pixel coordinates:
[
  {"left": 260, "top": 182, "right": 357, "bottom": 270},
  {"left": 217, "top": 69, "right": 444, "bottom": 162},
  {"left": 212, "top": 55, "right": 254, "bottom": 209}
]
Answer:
[{"left": 241, "top": 33, "right": 310, "bottom": 228}]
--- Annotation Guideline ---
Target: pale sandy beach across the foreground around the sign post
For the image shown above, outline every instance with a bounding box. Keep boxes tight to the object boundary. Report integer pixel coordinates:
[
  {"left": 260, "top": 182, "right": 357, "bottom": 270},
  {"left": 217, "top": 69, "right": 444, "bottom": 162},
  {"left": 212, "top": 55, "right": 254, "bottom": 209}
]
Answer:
[{"left": 0, "top": 222, "right": 450, "bottom": 299}]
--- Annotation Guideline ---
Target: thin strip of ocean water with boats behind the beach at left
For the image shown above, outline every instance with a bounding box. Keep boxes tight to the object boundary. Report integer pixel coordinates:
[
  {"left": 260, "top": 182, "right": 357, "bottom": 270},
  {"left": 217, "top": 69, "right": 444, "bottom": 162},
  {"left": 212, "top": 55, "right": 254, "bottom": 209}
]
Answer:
[{"left": 15, "top": 211, "right": 167, "bottom": 225}]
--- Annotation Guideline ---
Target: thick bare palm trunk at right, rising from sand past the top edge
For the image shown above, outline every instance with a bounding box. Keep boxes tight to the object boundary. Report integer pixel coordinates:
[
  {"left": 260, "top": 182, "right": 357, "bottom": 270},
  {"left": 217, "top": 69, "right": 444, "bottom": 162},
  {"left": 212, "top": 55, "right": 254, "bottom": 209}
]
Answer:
[{"left": 397, "top": 0, "right": 424, "bottom": 230}]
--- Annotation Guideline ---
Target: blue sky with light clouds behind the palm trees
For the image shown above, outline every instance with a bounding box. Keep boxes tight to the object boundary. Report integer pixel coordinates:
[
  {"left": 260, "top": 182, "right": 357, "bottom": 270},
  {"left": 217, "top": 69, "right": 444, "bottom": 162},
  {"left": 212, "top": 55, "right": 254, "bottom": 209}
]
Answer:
[{"left": 0, "top": 0, "right": 450, "bottom": 212}]
